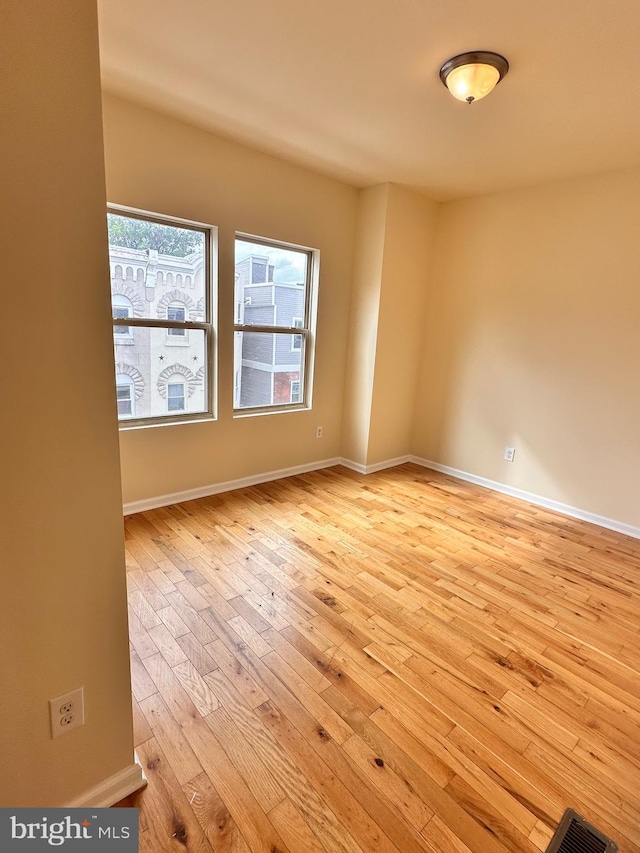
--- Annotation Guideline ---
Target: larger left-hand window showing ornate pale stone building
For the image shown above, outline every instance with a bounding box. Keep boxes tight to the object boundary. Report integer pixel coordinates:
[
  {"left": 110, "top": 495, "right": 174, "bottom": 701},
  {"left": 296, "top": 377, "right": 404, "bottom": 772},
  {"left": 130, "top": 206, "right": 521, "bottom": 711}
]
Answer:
[{"left": 107, "top": 207, "right": 215, "bottom": 428}]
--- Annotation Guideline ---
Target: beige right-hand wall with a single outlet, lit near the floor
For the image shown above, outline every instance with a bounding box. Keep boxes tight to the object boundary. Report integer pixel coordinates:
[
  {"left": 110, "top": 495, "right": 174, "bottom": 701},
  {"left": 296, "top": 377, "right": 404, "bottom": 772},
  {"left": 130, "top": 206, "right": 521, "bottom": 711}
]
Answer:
[{"left": 413, "top": 170, "right": 640, "bottom": 525}]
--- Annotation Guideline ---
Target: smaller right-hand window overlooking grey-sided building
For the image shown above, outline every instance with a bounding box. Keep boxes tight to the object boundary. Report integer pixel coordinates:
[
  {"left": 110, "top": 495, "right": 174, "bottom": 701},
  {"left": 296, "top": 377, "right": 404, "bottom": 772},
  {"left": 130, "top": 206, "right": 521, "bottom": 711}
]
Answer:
[{"left": 234, "top": 235, "right": 318, "bottom": 414}]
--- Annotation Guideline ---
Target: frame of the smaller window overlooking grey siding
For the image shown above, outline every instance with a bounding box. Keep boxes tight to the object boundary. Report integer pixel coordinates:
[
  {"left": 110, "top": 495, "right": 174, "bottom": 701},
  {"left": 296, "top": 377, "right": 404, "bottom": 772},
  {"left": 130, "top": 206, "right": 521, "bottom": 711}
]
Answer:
[{"left": 233, "top": 232, "right": 320, "bottom": 417}]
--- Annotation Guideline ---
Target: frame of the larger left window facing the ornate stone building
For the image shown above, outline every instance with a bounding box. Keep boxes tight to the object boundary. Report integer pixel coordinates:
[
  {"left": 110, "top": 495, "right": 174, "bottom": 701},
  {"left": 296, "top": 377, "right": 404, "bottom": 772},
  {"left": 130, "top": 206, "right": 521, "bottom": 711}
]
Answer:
[{"left": 107, "top": 204, "right": 218, "bottom": 430}]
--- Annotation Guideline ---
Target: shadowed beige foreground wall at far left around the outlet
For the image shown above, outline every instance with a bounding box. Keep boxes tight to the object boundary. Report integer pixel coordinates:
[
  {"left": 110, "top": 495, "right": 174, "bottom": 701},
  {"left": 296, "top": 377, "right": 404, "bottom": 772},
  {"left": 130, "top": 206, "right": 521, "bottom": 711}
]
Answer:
[{"left": 0, "top": 0, "right": 133, "bottom": 806}]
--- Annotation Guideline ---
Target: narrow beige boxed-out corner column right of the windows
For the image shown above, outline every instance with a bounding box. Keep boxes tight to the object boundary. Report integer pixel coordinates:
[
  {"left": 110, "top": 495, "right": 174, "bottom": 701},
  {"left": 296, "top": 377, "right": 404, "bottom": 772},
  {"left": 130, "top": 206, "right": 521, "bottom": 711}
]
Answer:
[{"left": 342, "top": 184, "right": 438, "bottom": 465}]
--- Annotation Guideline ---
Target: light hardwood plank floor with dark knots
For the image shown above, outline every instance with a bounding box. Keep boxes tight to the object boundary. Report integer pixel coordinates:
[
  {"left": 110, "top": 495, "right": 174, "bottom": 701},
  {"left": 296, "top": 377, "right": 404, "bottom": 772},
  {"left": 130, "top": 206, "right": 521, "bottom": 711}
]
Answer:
[{"left": 116, "top": 465, "right": 640, "bottom": 853}]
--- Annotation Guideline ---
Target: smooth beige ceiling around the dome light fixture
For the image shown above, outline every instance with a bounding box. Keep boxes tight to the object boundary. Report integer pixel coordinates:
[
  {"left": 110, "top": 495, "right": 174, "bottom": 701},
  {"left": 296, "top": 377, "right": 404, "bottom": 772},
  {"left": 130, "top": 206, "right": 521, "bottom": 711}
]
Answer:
[{"left": 99, "top": 0, "right": 640, "bottom": 200}]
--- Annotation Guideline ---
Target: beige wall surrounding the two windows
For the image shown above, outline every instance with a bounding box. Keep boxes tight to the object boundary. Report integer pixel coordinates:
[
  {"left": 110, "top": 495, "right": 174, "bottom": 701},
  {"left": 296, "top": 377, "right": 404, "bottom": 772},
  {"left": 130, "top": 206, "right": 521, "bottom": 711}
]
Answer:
[{"left": 104, "top": 95, "right": 357, "bottom": 502}]
